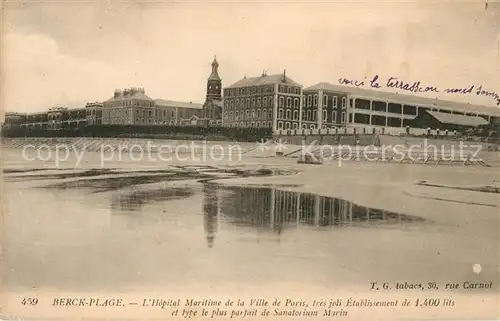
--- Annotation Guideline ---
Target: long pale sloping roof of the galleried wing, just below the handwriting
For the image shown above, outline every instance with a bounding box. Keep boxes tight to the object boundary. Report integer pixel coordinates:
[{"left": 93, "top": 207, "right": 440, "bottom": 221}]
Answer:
[{"left": 304, "top": 82, "right": 500, "bottom": 116}]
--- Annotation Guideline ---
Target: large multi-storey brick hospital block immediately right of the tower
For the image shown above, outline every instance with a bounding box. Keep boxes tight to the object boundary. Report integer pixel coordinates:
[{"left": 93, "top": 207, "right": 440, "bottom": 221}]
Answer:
[{"left": 223, "top": 72, "right": 302, "bottom": 130}]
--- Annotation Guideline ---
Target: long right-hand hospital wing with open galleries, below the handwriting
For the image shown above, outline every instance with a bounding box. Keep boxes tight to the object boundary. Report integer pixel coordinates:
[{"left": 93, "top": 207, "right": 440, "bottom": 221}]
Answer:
[{"left": 303, "top": 82, "right": 500, "bottom": 130}]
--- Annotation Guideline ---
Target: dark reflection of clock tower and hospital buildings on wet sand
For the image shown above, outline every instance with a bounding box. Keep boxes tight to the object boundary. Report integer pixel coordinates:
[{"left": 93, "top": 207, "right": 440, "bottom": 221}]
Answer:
[{"left": 203, "top": 184, "right": 424, "bottom": 247}]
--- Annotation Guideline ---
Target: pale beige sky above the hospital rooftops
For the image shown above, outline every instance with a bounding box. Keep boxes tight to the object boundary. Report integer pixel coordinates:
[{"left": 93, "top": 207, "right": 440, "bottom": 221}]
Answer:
[{"left": 1, "top": 0, "right": 500, "bottom": 112}]
